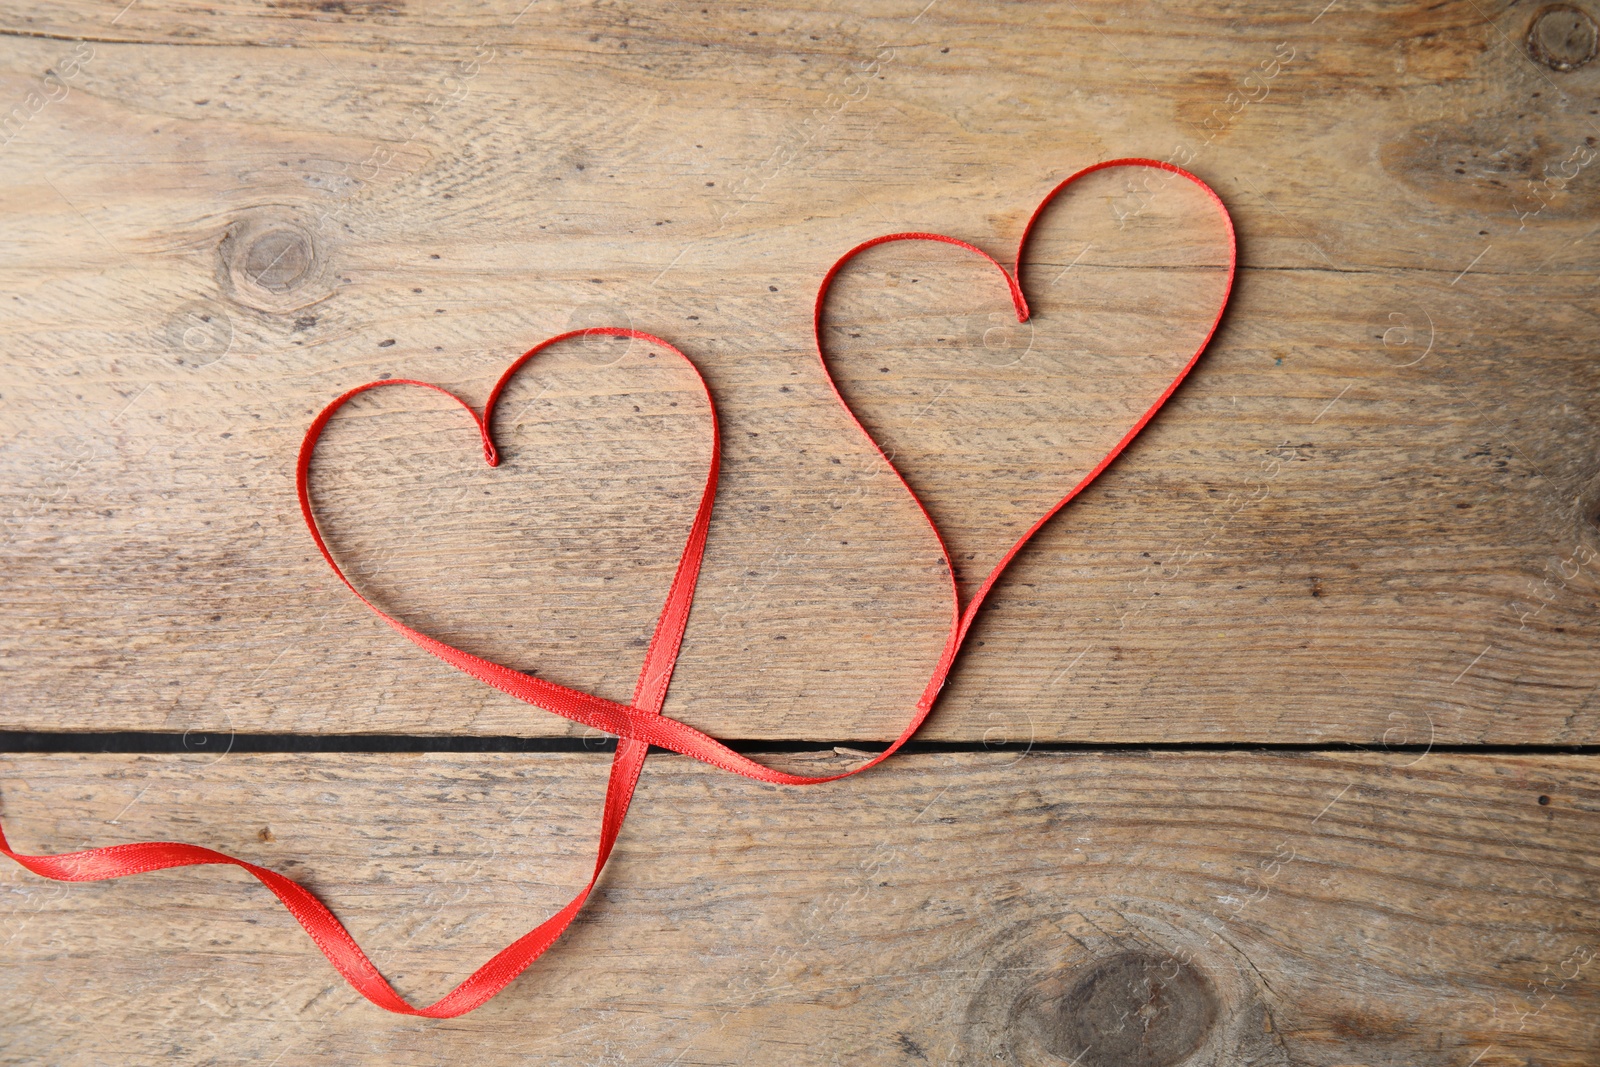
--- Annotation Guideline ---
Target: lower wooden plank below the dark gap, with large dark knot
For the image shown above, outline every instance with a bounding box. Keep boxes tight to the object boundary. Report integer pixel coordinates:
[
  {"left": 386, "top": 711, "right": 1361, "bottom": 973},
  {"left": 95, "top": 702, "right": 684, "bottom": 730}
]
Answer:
[{"left": 0, "top": 753, "right": 1600, "bottom": 1067}]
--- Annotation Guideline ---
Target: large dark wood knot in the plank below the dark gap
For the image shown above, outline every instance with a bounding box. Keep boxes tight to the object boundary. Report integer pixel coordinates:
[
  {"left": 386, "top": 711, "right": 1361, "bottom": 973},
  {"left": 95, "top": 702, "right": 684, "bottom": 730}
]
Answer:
[{"left": 1051, "top": 952, "right": 1221, "bottom": 1067}]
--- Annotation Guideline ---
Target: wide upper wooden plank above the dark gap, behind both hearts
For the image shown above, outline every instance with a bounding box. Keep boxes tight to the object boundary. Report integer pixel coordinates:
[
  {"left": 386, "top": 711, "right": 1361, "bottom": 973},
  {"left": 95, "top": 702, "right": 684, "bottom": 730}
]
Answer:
[{"left": 0, "top": 0, "right": 1600, "bottom": 744}]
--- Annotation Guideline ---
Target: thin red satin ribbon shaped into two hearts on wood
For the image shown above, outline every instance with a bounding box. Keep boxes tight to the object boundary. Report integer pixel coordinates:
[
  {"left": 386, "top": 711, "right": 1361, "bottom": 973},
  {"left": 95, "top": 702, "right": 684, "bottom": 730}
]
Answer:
[{"left": 0, "top": 158, "right": 1237, "bottom": 1019}]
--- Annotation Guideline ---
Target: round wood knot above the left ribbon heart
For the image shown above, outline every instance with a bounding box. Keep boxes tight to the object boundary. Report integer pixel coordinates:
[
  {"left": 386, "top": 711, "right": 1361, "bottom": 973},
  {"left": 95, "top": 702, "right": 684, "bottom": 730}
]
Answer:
[{"left": 218, "top": 208, "right": 328, "bottom": 314}]
